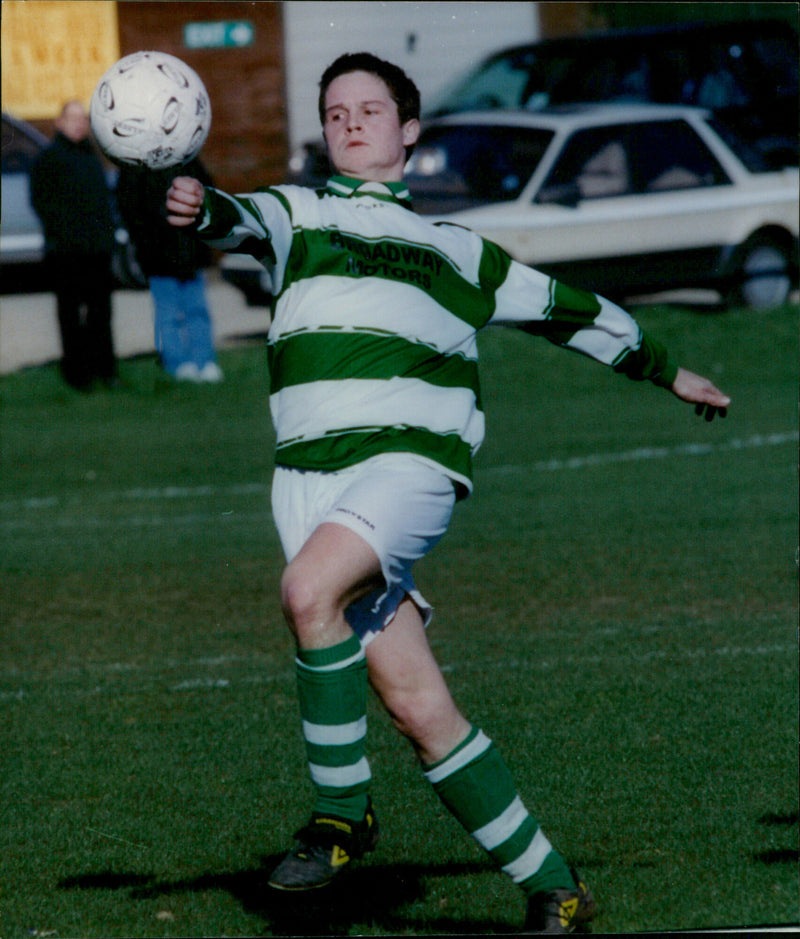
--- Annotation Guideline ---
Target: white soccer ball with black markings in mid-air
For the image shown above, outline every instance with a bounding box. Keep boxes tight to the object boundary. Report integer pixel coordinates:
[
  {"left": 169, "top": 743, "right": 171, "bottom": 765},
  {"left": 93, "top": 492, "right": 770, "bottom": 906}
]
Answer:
[{"left": 89, "top": 52, "right": 211, "bottom": 170}]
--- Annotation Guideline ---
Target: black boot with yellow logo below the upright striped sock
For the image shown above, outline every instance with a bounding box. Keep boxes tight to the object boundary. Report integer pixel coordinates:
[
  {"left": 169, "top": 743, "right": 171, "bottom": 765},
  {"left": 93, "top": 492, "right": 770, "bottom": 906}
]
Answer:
[{"left": 269, "top": 802, "right": 379, "bottom": 891}]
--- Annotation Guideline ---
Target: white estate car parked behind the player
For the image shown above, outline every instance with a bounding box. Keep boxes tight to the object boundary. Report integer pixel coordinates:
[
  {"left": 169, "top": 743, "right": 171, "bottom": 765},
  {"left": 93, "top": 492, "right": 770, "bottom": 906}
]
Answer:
[{"left": 221, "top": 104, "right": 799, "bottom": 308}]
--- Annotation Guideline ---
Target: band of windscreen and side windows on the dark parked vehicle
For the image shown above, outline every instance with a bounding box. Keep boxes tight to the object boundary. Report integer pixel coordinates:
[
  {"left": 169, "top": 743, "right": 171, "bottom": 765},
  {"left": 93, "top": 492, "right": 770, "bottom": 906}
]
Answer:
[{"left": 426, "top": 23, "right": 798, "bottom": 117}]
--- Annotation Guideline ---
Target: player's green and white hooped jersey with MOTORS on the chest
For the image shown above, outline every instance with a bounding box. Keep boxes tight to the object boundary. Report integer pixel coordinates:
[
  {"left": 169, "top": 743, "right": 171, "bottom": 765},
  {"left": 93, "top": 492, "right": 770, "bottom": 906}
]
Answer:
[{"left": 197, "top": 176, "right": 676, "bottom": 496}]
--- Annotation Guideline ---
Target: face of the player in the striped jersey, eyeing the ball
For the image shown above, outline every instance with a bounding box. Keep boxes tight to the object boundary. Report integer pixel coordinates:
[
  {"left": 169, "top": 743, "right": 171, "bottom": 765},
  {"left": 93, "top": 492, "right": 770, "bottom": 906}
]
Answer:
[{"left": 323, "top": 72, "right": 419, "bottom": 182}]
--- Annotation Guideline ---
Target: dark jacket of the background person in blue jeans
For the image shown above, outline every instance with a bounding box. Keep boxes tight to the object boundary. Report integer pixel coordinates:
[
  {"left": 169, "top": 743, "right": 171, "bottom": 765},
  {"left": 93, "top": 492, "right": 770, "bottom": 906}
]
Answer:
[{"left": 117, "top": 159, "right": 211, "bottom": 279}]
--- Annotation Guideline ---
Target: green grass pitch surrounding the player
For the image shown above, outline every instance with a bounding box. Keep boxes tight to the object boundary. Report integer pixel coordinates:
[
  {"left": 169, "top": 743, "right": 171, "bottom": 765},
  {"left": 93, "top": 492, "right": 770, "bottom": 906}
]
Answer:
[{"left": 0, "top": 307, "right": 800, "bottom": 939}]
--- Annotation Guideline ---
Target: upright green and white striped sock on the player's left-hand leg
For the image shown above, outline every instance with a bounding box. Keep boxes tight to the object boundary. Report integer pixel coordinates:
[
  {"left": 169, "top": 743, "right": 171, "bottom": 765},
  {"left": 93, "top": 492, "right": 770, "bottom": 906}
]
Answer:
[{"left": 295, "top": 636, "right": 371, "bottom": 822}]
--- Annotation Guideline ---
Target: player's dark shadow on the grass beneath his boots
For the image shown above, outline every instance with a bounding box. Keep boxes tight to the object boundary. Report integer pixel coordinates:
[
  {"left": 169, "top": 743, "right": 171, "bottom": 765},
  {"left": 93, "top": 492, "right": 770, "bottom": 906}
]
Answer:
[{"left": 58, "top": 855, "right": 521, "bottom": 936}]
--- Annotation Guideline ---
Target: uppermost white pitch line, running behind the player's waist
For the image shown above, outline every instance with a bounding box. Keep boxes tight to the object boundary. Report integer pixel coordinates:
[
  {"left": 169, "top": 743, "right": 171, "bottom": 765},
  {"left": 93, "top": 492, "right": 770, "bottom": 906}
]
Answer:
[{"left": 0, "top": 430, "right": 800, "bottom": 527}]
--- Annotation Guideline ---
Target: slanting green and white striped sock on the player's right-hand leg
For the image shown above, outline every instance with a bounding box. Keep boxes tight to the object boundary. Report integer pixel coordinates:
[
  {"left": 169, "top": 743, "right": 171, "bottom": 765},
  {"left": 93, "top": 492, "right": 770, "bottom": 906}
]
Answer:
[{"left": 423, "top": 727, "right": 573, "bottom": 895}]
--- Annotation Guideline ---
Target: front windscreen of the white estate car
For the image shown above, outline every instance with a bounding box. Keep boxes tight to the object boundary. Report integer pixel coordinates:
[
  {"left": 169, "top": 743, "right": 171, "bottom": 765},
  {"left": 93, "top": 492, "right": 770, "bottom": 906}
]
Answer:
[{"left": 406, "top": 124, "right": 553, "bottom": 213}]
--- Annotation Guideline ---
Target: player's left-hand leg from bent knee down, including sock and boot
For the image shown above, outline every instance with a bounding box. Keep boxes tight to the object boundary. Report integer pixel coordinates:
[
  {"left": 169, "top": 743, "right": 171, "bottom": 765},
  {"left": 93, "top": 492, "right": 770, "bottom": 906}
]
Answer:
[{"left": 270, "top": 523, "right": 382, "bottom": 891}]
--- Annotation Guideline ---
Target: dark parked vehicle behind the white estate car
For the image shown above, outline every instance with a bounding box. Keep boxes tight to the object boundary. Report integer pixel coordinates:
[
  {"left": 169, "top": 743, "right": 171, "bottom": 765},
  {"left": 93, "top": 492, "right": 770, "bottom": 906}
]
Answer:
[{"left": 288, "top": 20, "right": 800, "bottom": 186}]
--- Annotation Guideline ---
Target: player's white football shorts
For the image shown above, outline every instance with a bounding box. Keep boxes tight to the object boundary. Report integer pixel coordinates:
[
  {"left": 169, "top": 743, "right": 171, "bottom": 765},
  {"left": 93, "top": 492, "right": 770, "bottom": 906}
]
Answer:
[{"left": 272, "top": 453, "right": 455, "bottom": 645}]
